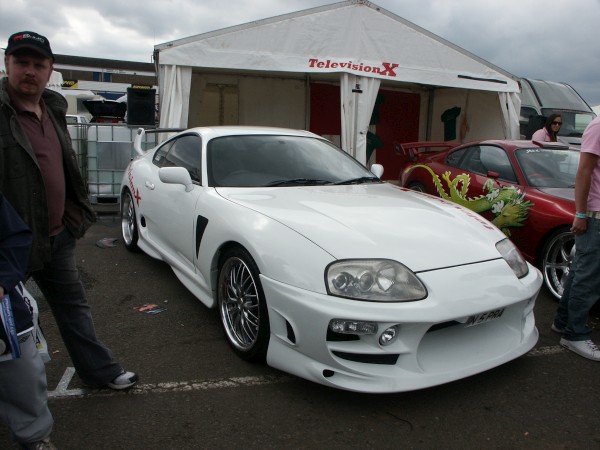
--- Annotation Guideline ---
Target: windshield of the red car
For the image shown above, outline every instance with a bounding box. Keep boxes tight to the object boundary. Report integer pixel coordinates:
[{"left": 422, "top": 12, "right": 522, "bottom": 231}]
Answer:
[{"left": 515, "top": 148, "right": 579, "bottom": 188}]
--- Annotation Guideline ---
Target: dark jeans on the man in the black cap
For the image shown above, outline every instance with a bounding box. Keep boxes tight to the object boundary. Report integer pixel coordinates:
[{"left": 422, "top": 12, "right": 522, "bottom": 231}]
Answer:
[{"left": 32, "top": 229, "right": 122, "bottom": 386}]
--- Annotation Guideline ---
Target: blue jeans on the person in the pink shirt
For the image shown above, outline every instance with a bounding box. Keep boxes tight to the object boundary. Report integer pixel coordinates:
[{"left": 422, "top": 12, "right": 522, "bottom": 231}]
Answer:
[{"left": 554, "top": 218, "right": 600, "bottom": 341}]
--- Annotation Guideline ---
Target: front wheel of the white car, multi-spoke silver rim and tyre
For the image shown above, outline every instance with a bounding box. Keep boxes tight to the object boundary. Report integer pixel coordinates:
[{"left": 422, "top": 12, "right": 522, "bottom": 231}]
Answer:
[{"left": 217, "top": 247, "right": 270, "bottom": 362}]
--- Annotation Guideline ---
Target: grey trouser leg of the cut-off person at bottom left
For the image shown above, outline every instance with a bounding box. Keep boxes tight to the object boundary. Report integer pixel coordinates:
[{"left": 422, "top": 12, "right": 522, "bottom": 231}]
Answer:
[{"left": 0, "top": 333, "right": 54, "bottom": 444}]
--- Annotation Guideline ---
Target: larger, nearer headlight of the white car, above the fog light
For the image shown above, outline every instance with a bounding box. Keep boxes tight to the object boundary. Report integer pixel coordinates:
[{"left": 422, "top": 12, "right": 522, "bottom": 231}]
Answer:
[{"left": 325, "top": 259, "right": 427, "bottom": 302}]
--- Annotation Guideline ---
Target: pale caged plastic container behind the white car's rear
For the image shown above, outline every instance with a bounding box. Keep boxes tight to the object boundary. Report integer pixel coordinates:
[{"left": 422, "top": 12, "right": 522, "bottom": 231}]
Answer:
[{"left": 85, "top": 124, "right": 158, "bottom": 204}]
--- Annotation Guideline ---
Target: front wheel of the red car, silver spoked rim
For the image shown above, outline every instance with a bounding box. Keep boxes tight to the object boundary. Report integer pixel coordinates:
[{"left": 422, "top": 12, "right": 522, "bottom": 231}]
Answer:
[{"left": 541, "top": 227, "right": 575, "bottom": 299}]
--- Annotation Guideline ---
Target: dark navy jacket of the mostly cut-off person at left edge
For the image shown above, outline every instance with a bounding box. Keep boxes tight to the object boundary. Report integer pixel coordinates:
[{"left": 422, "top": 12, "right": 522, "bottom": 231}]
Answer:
[{"left": 0, "top": 193, "right": 33, "bottom": 342}]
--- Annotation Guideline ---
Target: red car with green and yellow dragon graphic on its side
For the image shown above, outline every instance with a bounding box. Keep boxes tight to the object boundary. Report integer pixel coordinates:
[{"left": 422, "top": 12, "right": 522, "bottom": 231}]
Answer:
[{"left": 400, "top": 140, "right": 579, "bottom": 298}]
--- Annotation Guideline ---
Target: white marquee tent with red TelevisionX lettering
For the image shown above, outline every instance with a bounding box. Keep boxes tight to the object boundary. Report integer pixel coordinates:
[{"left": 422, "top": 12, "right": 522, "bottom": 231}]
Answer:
[{"left": 154, "top": 0, "right": 520, "bottom": 167}]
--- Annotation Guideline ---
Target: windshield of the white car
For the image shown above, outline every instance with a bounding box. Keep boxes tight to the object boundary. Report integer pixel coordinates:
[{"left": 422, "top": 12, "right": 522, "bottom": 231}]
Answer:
[{"left": 207, "top": 135, "right": 380, "bottom": 187}]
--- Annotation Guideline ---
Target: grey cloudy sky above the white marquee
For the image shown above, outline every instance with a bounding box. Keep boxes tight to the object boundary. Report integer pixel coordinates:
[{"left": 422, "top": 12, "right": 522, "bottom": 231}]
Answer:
[{"left": 0, "top": 0, "right": 600, "bottom": 106}]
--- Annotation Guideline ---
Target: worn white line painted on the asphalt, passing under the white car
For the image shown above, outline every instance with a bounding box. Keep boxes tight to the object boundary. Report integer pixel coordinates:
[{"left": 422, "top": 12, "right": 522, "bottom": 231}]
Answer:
[{"left": 48, "top": 345, "right": 565, "bottom": 399}]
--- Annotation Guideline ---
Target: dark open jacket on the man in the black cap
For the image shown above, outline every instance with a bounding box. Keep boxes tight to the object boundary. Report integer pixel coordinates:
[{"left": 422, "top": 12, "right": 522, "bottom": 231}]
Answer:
[{"left": 0, "top": 78, "right": 96, "bottom": 272}]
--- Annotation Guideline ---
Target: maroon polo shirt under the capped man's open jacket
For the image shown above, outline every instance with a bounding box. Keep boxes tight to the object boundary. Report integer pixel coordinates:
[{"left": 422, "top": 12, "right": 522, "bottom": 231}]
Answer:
[{"left": 9, "top": 89, "right": 66, "bottom": 236}]
